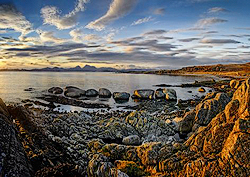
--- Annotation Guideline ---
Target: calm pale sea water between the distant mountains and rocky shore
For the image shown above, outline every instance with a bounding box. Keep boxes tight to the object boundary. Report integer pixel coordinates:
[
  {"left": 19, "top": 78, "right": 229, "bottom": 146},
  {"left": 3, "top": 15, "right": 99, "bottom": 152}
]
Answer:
[{"left": 0, "top": 72, "right": 217, "bottom": 110}]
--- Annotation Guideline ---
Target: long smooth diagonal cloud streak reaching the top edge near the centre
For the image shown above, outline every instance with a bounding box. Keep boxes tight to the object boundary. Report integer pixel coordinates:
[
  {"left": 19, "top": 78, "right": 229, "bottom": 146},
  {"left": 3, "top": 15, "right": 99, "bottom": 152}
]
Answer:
[{"left": 86, "top": 0, "right": 137, "bottom": 31}]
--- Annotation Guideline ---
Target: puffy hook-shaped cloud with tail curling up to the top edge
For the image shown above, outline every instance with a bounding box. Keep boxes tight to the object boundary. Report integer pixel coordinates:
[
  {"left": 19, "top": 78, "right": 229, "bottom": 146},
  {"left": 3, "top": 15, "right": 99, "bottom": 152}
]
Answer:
[{"left": 41, "top": 0, "right": 89, "bottom": 30}]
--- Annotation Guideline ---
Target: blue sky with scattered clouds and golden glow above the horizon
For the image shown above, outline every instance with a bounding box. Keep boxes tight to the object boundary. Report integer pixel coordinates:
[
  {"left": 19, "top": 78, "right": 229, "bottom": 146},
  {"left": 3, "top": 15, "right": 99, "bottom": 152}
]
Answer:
[{"left": 0, "top": 0, "right": 250, "bottom": 69}]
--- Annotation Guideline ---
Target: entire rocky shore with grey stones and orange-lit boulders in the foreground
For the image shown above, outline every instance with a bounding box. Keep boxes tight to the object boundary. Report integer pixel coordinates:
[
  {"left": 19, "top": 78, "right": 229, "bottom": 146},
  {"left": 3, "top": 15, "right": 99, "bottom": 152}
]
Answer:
[{"left": 0, "top": 79, "right": 250, "bottom": 177}]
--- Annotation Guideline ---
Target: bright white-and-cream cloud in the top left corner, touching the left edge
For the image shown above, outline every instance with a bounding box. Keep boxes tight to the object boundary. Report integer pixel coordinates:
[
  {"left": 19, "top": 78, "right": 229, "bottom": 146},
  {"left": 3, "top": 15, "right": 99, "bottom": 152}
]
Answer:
[{"left": 0, "top": 4, "right": 33, "bottom": 39}]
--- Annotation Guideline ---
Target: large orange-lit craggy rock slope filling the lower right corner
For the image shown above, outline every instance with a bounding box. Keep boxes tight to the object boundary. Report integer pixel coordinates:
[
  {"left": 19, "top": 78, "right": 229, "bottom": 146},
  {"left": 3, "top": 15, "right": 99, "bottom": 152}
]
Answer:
[{"left": 159, "top": 79, "right": 250, "bottom": 177}]
